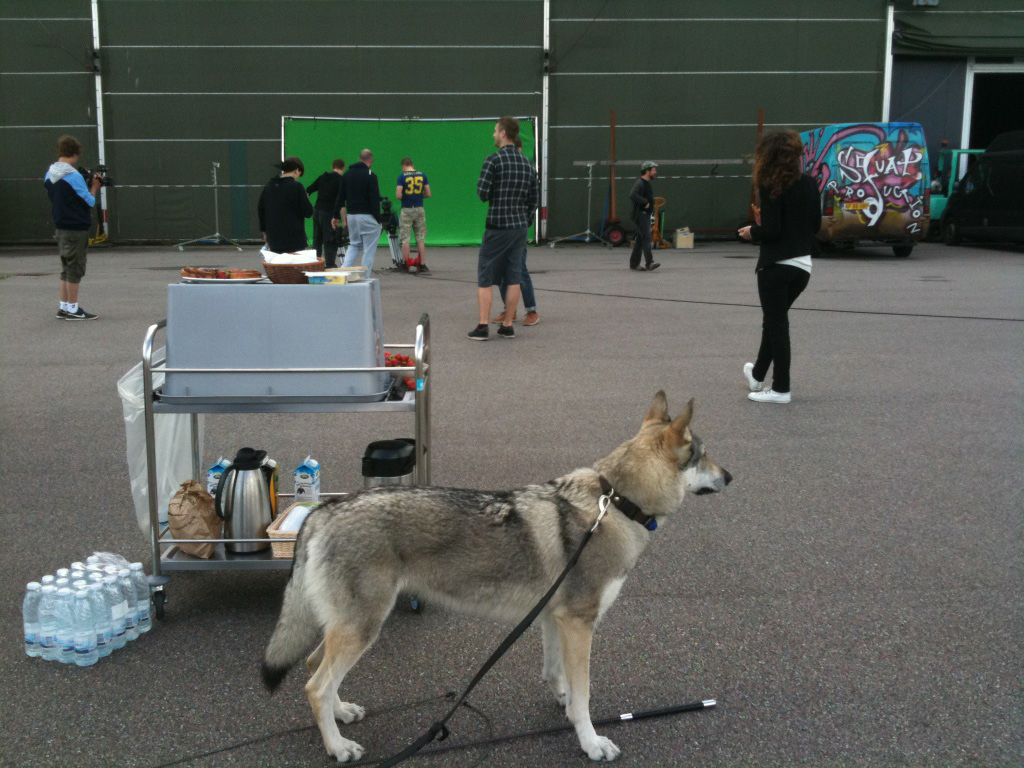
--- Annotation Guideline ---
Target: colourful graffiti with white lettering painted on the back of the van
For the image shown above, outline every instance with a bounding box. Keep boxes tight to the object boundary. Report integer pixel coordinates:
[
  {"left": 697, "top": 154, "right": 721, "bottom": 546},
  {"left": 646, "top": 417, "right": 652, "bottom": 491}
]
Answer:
[{"left": 804, "top": 123, "right": 928, "bottom": 234}]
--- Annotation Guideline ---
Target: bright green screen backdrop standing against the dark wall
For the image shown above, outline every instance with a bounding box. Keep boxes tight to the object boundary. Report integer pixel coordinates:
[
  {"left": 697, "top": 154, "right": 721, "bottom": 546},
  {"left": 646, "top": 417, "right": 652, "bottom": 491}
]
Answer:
[{"left": 284, "top": 117, "right": 536, "bottom": 246}]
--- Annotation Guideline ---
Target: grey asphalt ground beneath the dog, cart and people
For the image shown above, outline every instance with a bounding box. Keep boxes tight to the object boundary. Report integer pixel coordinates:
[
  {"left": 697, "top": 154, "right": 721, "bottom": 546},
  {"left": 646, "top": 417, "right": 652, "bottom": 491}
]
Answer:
[{"left": 0, "top": 237, "right": 1024, "bottom": 768}]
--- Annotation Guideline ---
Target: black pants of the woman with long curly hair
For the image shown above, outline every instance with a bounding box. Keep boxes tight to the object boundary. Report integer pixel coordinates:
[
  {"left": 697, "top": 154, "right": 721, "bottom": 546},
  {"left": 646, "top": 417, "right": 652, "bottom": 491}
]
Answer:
[{"left": 754, "top": 264, "right": 811, "bottom": 392}]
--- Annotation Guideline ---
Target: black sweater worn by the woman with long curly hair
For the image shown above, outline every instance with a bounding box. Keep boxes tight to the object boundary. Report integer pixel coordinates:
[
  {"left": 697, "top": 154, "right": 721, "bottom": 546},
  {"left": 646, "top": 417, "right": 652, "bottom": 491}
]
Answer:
[{"left": 751, "top": 173, "right": 821, "bottom": 271}]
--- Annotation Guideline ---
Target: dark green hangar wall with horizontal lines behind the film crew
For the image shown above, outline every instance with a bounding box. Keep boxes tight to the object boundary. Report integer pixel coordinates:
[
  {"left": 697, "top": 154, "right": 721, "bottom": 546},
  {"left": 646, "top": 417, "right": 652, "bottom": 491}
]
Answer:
[{"left": 0, "top": 0, "right": 886, "bottom": 243}]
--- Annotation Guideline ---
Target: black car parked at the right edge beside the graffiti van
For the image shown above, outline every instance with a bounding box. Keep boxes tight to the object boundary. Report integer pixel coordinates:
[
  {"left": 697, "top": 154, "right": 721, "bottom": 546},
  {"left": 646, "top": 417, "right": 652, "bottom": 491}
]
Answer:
[{"left": 941, "top": 131, "right": 1024, "bottom": 246}]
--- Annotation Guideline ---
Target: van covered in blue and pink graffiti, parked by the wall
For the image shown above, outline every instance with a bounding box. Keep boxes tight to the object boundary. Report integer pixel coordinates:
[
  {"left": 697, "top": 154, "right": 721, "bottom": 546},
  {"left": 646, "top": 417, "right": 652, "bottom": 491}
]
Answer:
[{"left": 800, "top": 123, "right": 931, "bottom": 256}]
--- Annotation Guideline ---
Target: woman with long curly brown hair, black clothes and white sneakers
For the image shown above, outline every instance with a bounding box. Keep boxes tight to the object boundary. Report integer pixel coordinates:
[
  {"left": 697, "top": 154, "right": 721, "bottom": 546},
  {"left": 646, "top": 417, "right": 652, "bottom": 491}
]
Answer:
[{"left": 738, "top": 131, "right": 821, "bottom": 402}]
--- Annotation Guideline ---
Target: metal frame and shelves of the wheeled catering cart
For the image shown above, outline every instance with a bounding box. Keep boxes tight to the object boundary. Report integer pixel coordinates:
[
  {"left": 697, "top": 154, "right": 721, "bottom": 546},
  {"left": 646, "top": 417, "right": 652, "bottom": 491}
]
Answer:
[{"left": 142, "top": 307, "right": 430, "bottom": 618}]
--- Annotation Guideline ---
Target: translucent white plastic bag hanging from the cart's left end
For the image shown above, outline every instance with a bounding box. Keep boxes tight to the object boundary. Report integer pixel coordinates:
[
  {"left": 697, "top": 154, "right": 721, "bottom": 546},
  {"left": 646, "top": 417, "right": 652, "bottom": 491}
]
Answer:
[{"left": 118, "top": 349, "right": 203, "bottom": 539}]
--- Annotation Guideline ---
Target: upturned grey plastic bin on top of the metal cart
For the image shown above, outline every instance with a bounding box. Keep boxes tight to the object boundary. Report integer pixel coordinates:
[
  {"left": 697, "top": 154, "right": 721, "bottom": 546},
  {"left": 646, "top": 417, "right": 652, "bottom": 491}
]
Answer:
[{"left": 162, "top": 280, "right": 391, "bottom": 403}]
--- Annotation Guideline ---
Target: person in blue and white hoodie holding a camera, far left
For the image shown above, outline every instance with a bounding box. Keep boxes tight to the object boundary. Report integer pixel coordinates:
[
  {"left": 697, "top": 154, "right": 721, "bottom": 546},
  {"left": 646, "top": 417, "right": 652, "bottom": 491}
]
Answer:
[{"left": 43, "top": 135, "right": 101, "bottom": 319}]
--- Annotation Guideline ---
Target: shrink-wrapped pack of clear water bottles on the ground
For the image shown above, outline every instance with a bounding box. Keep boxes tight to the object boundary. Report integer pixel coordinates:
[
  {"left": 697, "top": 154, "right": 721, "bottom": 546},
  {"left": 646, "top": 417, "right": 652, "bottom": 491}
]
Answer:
[{"left": 22, "top": 552, "right": 153, "bottom": 667}]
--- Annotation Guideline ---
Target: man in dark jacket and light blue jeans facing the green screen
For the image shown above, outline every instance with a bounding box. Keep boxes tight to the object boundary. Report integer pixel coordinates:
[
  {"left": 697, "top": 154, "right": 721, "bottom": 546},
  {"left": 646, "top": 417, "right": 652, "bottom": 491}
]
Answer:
[{"left": 331, "top": 150, "right": 381, "bottom": 278}]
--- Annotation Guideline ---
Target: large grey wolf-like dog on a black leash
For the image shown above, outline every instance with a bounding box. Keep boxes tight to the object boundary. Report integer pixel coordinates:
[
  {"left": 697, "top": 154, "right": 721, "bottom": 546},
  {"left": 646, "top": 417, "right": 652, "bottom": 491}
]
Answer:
[{"left": 263, "top": 392, "right": 732, "bottom": 763}]
